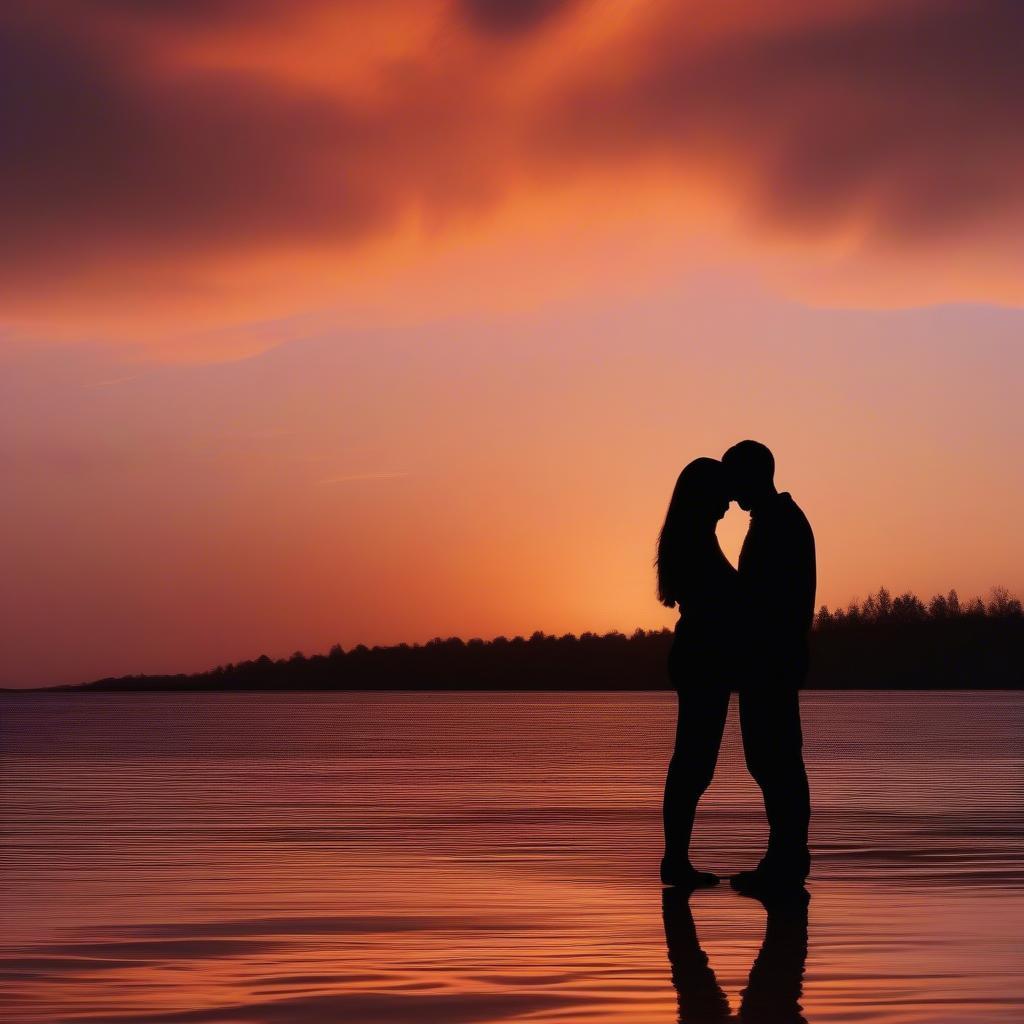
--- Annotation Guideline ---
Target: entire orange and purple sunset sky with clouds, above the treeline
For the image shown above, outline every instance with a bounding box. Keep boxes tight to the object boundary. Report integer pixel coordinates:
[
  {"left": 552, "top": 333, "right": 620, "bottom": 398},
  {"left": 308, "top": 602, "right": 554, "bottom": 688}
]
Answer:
[{"left": 0, "top": 0, "right": 1024, "bottom": 686}]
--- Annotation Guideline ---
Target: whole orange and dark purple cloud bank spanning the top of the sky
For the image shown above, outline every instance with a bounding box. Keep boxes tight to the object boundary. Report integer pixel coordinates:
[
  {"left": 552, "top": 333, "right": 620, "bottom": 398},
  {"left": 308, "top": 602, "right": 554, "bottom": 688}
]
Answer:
[{"left": 0, "top": 0, "right": 1024, "bottom": 335}]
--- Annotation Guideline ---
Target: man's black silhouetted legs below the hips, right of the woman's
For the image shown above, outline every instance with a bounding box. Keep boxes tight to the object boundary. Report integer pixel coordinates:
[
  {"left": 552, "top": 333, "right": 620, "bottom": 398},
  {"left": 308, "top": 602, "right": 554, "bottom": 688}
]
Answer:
[{"left": 739, "top": 680, "right": 811, "bottom": 882}]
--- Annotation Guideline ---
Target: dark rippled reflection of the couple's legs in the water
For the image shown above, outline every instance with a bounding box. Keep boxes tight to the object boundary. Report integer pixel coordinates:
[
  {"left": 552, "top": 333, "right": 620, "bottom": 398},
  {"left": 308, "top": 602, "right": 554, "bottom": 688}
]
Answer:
[{"left": 662, "top": 889, "right": 810, "bottom": 1024}]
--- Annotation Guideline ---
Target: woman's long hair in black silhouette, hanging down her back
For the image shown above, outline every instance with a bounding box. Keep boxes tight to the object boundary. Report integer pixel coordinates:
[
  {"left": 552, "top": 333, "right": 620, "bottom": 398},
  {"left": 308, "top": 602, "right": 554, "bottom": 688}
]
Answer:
[{"left": 654, "top": 458, "right": 725, "bottom": 608}]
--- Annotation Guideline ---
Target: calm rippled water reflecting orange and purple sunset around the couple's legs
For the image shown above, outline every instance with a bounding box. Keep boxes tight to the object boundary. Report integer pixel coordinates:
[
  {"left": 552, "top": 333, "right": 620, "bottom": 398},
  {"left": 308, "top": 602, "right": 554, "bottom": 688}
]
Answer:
[{"left": 0, "top": 692, "right": 1024, "bottom": 1024}]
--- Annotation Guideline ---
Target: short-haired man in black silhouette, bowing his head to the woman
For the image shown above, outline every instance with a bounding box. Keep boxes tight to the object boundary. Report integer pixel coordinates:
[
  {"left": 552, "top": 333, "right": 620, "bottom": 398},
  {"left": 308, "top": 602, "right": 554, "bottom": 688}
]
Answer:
[{"left": 722, "top": 440, "right": 815, "bottom": 890}]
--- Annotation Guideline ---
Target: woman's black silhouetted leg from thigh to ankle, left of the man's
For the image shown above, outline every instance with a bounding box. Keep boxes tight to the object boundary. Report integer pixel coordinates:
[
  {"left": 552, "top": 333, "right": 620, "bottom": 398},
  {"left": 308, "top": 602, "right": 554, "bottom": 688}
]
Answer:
[{"left": 663, "top": 683, "right": 729, "bottom": 873}]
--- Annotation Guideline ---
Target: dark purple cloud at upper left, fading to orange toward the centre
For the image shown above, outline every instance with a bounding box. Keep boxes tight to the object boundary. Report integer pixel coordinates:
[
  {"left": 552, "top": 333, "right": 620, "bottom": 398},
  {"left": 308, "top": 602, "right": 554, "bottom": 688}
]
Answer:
[{"left": 0, "top": 7, "right": 487, "bottom": 287}]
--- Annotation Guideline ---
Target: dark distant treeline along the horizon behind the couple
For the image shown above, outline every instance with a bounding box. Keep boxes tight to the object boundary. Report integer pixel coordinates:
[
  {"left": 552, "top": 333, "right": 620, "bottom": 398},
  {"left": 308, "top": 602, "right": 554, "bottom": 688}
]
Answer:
[{"left": 60, "top": 589, "right": 1024, "bottom": 690}]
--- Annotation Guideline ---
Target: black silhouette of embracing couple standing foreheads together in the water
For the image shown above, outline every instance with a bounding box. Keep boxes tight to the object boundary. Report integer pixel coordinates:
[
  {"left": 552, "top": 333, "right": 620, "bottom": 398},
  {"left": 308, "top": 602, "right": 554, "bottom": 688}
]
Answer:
[{"left": 657, "top": 440, "right": 815, "bottom": 893}]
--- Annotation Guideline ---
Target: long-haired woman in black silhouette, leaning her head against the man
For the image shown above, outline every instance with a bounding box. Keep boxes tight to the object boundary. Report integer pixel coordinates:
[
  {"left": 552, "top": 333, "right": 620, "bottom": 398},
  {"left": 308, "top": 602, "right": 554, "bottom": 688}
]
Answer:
[{"left": 657, "top": 459, "right": 739, "bottom": 889}]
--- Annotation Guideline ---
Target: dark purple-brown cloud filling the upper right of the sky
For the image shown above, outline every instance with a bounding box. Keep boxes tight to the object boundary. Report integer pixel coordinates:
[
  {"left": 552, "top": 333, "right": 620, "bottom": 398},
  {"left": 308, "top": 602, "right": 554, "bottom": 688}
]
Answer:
[{"left": 538, "top": 0, "right": 1024, "bottom": 236}]
